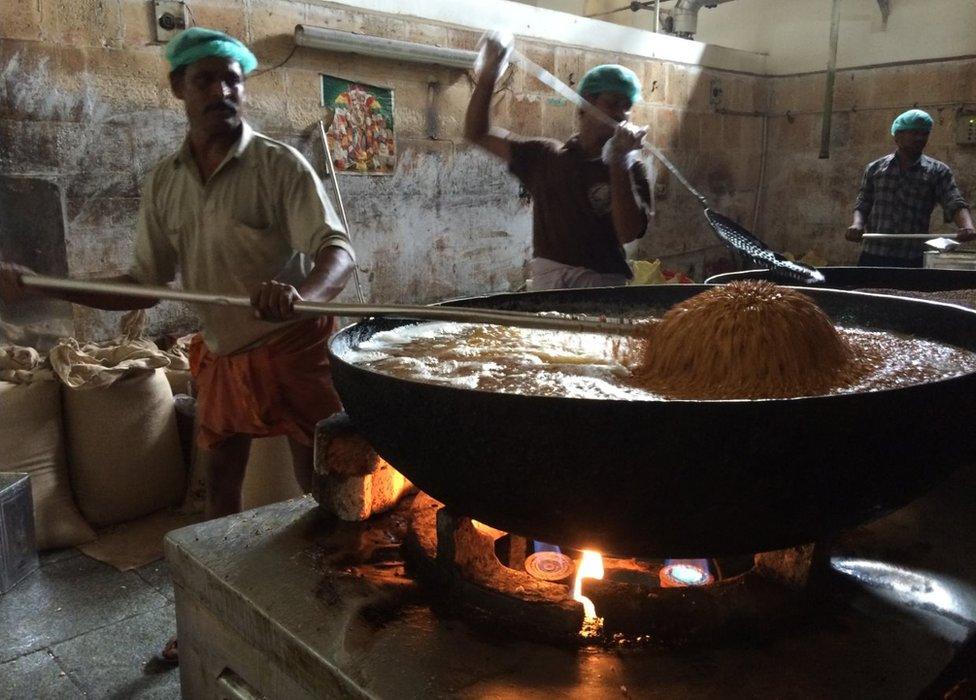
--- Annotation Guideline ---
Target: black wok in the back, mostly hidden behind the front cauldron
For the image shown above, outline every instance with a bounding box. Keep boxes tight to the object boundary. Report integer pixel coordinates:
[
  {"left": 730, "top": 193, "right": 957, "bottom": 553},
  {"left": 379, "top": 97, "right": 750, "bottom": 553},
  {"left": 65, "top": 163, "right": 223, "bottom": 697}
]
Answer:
[{"left": 705, "top": 267, "right": 976, "bottom": 292}]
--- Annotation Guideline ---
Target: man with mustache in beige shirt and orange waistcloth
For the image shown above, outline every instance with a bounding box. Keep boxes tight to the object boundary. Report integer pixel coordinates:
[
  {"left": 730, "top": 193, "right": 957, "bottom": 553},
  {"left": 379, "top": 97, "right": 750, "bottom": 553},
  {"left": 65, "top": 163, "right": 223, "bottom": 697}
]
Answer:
[{"left": 0, "top": 27, "right": 354, "bottom": 584}]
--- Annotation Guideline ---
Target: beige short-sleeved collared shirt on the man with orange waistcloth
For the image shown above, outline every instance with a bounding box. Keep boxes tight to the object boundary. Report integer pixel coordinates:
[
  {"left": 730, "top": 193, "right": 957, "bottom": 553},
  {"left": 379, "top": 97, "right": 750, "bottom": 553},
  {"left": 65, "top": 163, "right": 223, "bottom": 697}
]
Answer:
[{"left": 129, "top": 123, "right": 355, "bottom": 355}]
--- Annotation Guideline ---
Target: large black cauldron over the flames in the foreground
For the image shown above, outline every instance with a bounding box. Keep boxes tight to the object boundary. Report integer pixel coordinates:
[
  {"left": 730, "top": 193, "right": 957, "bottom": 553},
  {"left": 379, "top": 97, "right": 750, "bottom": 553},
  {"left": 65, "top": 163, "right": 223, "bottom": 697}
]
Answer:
[{"left": 330, "top": 285, "right": 976, "bottom": 557}]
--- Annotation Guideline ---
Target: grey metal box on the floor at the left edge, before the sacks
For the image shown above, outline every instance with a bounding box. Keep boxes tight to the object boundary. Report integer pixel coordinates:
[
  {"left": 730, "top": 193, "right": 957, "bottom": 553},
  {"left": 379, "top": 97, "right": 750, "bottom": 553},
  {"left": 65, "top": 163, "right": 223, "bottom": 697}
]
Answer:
[{"left": 0, "top": 473, "right": 37, "bottom": 593}]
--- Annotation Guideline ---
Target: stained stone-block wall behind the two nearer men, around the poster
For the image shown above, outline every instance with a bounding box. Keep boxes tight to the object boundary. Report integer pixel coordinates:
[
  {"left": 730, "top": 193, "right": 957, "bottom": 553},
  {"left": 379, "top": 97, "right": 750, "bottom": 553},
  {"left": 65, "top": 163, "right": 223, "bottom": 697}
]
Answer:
[{"left": 0, "top": 0, "right": 766, "bottom": 338}]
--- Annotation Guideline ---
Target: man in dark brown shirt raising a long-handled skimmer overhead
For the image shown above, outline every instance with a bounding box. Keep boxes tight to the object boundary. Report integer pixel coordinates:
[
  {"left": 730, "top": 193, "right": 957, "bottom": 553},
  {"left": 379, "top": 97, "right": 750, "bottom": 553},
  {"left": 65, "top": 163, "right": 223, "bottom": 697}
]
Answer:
[{"left": 464, "top": 38, "right": 651, "bottom": 289}]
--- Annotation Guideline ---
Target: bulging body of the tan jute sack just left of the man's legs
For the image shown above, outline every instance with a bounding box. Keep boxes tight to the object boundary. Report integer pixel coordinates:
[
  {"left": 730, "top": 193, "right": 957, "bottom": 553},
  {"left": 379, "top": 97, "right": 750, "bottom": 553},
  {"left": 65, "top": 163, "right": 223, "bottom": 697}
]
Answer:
[{"left": 64, "top": 369, "right": 186, "bottom": 526}]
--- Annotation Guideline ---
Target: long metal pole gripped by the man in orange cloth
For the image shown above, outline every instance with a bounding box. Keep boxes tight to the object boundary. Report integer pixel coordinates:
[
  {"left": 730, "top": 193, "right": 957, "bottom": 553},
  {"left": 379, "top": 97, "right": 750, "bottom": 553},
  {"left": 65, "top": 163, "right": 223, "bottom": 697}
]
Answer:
[{"left": 21, "top": 275, "right": 646, "bottom": 335}]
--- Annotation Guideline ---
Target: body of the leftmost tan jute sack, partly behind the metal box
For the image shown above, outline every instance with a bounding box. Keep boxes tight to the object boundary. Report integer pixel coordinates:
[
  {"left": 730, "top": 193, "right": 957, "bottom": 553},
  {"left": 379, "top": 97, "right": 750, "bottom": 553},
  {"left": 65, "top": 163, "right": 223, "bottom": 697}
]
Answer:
[{"left": 0, "top": 379, "right": 95, "bottom": 550}]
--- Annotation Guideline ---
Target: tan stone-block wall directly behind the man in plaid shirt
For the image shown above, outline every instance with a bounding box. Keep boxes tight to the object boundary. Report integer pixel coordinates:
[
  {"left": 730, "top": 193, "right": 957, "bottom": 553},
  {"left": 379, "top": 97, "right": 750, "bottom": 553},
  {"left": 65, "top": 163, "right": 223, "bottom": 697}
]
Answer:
[{"left": 758, "top": 58, "right": 976, "bottom": 264}]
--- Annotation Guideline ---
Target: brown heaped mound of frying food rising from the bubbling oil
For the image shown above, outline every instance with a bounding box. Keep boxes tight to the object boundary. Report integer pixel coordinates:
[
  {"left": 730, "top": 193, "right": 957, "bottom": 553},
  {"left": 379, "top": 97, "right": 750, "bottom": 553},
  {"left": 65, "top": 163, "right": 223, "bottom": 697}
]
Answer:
[{"left": 633, "top": 281, "right": 869, "bottom": 399}]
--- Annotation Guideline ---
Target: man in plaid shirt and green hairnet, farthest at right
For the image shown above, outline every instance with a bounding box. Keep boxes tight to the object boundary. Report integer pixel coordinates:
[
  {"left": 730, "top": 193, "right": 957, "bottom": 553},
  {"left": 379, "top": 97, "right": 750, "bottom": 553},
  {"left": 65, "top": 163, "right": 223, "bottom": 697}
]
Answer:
[{"left": 847, "top": 109, "right": 976, "bottom": 267}]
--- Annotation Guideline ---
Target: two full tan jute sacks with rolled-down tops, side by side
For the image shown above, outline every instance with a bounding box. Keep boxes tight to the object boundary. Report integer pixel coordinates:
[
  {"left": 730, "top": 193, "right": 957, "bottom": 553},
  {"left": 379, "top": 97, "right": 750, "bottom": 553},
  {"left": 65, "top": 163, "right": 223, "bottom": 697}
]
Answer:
[{"left": 0, "top": 312, "right": 189, "bottom": 549}]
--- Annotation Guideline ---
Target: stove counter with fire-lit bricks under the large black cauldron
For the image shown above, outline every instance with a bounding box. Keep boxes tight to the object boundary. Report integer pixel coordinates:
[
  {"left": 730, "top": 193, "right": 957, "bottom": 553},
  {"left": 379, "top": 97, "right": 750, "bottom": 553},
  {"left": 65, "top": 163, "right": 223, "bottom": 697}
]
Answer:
[{"left": 166, "top": 418, "right": 976, "bottom": 698}]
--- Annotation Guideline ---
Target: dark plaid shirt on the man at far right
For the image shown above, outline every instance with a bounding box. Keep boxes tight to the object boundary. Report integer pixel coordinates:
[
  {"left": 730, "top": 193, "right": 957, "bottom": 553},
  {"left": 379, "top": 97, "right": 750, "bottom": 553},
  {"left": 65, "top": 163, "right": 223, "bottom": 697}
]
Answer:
[{"left": 854, "top": 153, "right": 969, "bottom": 258}]
